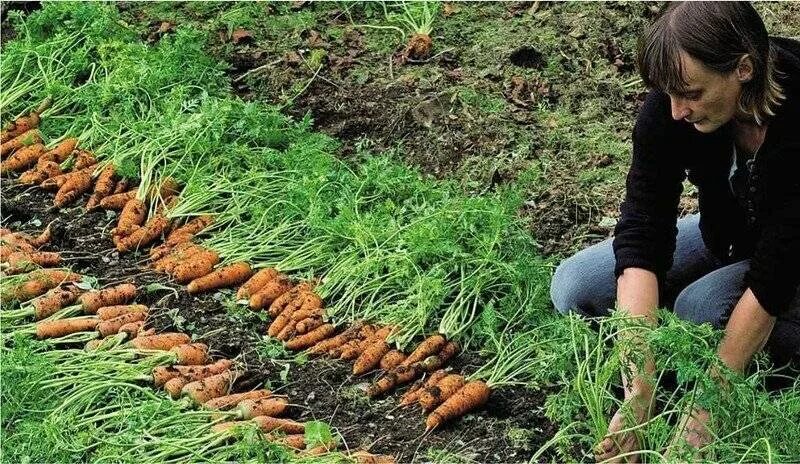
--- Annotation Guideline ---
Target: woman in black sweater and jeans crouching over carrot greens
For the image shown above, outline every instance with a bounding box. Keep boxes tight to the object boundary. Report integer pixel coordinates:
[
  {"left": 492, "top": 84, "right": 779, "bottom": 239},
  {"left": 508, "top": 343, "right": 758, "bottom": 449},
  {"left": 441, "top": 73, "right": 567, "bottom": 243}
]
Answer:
[{"left": 551, "top": 2, "right": 800, "bottom": 460}]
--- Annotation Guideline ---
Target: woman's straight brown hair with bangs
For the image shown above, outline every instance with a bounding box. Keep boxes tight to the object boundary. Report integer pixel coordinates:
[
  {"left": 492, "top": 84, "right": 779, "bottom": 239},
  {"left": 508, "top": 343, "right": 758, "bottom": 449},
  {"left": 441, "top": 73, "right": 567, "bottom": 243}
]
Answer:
[{"left": 636, "top": 2, "right": 785, "bottom": 124}]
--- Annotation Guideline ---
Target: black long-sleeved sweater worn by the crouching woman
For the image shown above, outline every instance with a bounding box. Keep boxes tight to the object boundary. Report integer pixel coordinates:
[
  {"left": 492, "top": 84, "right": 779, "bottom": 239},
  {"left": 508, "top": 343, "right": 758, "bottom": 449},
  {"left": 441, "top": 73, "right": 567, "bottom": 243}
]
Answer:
[{"left": 614, "top": 38, "right": 800, "bottom": 316}]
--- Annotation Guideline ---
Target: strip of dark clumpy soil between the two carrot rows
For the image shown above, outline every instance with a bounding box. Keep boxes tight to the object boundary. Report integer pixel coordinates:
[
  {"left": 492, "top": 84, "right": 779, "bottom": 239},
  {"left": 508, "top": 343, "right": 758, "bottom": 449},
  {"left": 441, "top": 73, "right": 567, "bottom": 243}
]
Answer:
[{"left": 0, "top": 179, "right": 556, "bottom": 463}]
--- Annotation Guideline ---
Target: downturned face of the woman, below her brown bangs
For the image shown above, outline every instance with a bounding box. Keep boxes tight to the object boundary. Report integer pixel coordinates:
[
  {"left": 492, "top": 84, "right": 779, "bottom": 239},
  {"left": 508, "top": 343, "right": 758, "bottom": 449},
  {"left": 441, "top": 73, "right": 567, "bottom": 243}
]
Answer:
[{"left": 667, "top": 52, "right": 752, "bottom": 133}]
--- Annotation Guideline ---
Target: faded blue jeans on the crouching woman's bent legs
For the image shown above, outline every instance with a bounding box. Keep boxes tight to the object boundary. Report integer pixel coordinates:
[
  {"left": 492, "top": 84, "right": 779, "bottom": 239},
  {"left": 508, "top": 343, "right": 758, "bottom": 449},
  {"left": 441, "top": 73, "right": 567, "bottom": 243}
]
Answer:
[{"left": 550, "top": 214, "right": 800, "bottom": 364}]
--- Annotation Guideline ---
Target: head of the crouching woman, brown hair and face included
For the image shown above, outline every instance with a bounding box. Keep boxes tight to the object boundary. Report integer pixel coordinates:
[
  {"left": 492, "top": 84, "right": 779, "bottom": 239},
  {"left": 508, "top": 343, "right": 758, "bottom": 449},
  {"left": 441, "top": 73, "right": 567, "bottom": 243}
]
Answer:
[{"left": 637, "top": 2, "right": 783, "bottom": 132}]
